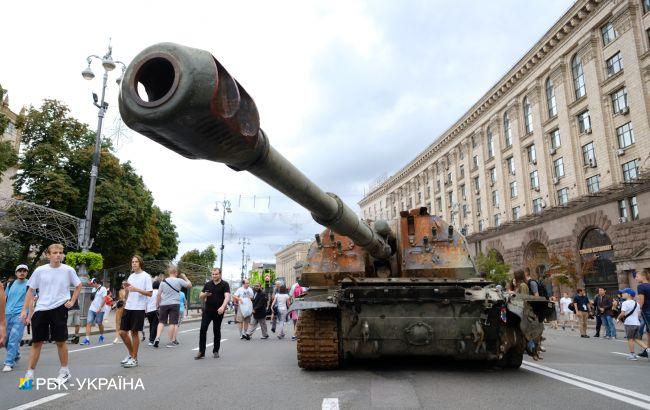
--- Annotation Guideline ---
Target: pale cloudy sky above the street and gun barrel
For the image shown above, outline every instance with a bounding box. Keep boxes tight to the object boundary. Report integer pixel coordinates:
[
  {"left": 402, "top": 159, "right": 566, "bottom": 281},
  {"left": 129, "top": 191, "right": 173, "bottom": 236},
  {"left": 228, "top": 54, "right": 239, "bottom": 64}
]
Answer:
[{"left": 0, "top": 0, "right": 573, "bottom": 278}]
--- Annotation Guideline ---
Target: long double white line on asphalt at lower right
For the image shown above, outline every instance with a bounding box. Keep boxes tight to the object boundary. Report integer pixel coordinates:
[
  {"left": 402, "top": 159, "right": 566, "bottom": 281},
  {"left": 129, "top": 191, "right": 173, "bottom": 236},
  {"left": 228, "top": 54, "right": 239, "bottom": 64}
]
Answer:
[{"left": 522, "top": 361, "right": 650, "bottom": 409}]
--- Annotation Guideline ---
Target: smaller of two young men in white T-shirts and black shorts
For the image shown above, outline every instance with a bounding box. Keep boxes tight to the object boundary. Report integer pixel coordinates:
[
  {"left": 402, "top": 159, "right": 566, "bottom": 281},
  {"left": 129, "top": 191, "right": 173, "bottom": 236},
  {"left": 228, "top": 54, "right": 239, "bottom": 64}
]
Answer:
[{"left": 120, "top": 255, "right": 153, "bottom": 368}]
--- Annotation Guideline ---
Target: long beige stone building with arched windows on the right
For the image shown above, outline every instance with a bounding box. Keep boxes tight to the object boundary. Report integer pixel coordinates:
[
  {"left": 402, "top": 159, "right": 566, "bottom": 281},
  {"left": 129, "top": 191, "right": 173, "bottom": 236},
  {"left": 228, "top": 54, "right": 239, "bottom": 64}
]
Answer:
[{"left": 359, "top": 0, "right": 650, "bottom": 292}]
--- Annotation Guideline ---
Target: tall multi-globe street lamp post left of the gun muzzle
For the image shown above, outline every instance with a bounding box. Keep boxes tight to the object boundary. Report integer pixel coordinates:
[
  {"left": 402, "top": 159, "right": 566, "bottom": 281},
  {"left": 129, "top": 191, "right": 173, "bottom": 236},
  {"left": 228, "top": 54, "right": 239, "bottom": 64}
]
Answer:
[{"left": 79, "top": 43, "right": 126, "bottom": 264}]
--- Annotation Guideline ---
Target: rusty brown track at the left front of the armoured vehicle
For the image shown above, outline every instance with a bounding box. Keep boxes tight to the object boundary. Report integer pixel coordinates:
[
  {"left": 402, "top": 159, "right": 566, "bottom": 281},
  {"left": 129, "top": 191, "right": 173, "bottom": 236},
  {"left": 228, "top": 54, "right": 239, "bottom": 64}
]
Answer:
[{"left": 297, "top": 309, "right": 340, "bottom": 370}]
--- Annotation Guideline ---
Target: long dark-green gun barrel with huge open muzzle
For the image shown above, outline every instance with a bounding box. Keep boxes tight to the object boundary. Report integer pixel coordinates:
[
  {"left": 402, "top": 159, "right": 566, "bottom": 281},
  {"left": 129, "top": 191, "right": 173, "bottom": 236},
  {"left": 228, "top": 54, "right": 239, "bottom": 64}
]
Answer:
[{"left": 119, "top": 43, "right": 391, "bottom": 259}]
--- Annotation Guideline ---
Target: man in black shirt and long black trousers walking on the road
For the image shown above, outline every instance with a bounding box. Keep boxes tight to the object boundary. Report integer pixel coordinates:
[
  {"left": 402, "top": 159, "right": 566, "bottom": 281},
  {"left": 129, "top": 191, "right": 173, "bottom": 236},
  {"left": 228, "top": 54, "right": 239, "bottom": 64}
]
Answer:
[{"left": 194, "top": 268, "right": 230, "bottom": 360}]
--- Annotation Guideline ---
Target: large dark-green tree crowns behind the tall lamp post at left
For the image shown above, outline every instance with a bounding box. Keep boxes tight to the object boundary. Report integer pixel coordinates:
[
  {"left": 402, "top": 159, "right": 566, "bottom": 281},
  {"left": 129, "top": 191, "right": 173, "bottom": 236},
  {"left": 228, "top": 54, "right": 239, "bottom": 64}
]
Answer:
[{"left": 14, "top": 100, "right": 177, "bottom": 266}]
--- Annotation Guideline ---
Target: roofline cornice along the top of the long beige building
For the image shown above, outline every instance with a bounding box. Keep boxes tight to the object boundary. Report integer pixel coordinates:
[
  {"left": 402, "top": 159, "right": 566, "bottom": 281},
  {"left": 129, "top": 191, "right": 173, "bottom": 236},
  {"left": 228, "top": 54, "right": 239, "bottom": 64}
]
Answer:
[{"left": 358, "top": 0, "right": 606, "bottom": 206}]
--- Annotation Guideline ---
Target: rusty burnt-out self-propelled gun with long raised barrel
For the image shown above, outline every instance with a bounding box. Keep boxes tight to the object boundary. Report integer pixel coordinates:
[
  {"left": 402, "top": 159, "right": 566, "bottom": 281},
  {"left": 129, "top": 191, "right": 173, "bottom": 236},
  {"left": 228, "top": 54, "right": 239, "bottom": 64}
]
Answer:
[{"left": 119, "top": 43, "right": 555, "bottom": 369}]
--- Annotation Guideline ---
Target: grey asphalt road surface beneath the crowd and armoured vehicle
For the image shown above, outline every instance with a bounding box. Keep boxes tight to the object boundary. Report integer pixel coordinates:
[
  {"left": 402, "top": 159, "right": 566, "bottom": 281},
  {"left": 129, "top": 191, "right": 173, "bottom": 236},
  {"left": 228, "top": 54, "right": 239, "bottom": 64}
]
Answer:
[{"left": 0, "top": 323, "right": 650, "bottom": 410}]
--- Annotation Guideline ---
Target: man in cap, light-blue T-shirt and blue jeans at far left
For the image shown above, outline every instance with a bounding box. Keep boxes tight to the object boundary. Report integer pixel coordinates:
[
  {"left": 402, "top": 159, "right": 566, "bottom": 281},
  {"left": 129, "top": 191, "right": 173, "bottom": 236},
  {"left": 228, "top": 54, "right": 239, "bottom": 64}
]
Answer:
[{"left": 0, "top": 265, "right": 33, "bottom": 372}]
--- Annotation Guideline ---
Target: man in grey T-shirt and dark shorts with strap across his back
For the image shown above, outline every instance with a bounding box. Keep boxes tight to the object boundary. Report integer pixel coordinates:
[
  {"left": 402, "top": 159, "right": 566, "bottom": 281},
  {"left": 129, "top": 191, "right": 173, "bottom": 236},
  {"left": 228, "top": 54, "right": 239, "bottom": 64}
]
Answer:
[{"left": 153, "top": 265, "right": 192, "bottom": 348}]
